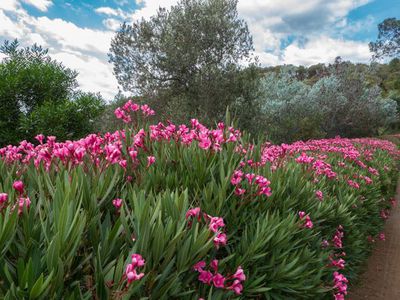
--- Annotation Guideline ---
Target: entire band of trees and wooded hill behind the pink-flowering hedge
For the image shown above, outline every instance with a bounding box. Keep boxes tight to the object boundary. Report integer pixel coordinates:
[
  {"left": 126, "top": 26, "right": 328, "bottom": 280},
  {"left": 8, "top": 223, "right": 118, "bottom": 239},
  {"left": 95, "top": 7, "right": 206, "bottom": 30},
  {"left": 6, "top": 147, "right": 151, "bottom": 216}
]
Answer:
[{"left": 0, "top": 0, "right": 400, "bottom": 145}]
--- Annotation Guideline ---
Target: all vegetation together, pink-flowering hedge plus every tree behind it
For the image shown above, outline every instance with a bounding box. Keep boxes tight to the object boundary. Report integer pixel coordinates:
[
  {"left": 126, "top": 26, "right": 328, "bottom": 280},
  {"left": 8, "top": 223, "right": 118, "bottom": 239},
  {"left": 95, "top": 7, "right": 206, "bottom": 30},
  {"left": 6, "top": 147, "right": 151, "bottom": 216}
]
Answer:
[{"left": 0, "top": 0, "right": 400, "bottom": 300}]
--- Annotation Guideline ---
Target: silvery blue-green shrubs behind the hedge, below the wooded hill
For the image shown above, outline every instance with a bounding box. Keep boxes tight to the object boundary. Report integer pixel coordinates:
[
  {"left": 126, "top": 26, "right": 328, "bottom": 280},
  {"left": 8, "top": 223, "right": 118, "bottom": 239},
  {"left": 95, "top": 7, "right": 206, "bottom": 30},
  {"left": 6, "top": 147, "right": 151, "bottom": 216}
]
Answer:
[{"left": 261, "top": 62, "right": 398, "bottom": 142}]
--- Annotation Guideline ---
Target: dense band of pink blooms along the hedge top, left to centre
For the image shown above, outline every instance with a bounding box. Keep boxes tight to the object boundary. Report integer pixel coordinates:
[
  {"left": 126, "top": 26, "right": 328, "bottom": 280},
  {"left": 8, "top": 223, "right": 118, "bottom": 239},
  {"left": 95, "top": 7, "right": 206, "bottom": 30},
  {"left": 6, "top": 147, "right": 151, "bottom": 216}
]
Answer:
[{"left": 0, "top": 108, "right": 241, "bottom": 170}]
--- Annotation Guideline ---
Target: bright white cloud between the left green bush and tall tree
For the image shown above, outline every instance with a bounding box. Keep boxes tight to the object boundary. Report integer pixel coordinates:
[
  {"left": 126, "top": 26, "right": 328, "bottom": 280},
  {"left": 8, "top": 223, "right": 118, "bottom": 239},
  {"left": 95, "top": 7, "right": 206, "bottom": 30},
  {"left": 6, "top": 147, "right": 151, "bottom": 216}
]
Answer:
[{"left": 0, "top": 0, "right": 118, "bottom": 100}]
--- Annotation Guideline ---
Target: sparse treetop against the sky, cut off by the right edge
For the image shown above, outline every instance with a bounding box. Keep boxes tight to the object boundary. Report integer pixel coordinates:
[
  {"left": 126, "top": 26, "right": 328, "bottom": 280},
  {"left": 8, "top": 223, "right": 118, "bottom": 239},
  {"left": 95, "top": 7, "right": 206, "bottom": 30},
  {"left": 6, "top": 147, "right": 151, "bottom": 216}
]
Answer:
[{"left": 369, "top": 18, "right": 400, "bottom": 59}]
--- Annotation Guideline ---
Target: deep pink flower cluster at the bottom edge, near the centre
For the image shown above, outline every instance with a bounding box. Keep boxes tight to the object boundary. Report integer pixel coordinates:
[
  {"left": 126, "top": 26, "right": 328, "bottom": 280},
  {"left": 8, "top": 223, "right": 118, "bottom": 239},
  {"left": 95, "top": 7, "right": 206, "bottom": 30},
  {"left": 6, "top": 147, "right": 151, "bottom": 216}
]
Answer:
[{"left": 193, "top": 259, "right": 246, "bottom": 295}]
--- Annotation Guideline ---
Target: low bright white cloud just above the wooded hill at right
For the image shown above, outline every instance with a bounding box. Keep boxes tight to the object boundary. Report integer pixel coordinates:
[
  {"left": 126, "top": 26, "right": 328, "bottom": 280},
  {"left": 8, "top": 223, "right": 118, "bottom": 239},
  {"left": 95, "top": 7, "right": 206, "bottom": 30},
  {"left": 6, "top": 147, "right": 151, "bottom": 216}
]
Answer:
[{"left": 283, "top": 36, "right": 371, "bottom": 66}]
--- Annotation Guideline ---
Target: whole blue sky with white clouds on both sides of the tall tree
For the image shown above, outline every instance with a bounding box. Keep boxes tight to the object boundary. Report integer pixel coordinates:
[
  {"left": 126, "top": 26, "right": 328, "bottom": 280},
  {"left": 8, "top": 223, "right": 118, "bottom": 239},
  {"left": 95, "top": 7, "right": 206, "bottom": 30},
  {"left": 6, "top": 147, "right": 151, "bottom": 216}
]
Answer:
[{"left": 0, "top": 0, "right": 400, "bottom": 100}]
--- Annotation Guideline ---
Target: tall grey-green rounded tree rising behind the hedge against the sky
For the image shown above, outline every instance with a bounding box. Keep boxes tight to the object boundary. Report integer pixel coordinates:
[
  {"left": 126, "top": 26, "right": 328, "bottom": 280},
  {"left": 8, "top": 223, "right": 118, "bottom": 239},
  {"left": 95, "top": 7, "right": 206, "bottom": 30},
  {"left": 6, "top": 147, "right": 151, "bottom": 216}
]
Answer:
[{"left": 109, "top": 0, "right": 253, "bottom": 120}]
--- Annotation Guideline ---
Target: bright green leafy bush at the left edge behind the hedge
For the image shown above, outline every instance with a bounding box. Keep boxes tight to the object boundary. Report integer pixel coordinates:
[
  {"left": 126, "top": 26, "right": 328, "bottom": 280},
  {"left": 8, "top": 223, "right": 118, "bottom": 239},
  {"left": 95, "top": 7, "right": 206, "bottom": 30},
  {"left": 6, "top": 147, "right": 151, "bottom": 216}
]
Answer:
[{"left": 0, "top": 40, "right": 105, "bottom": 146}]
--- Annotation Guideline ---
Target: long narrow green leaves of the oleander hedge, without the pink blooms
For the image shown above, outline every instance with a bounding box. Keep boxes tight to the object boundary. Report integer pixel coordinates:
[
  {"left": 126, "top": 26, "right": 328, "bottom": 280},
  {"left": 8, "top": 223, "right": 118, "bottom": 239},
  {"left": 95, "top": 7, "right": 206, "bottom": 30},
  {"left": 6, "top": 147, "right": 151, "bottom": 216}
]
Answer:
[{"left": 0, "top": 125, "right": 396, "bottom": 299}]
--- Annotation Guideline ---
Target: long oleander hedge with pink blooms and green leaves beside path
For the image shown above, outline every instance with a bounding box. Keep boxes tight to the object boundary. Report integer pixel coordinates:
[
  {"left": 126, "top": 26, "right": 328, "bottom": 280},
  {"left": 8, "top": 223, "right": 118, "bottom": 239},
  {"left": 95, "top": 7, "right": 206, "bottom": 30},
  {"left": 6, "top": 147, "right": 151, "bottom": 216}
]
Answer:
[{"left": 0, "top": 101, "right": 399, "bottom": 299}]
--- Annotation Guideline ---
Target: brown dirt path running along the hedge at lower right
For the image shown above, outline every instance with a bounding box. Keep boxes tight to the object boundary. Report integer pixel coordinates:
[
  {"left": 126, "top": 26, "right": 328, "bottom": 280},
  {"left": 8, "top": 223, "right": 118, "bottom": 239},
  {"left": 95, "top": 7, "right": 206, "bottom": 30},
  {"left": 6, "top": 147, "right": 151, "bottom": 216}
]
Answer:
[{"left": 348, "top": 184, "right": 400, "bottom": 300}]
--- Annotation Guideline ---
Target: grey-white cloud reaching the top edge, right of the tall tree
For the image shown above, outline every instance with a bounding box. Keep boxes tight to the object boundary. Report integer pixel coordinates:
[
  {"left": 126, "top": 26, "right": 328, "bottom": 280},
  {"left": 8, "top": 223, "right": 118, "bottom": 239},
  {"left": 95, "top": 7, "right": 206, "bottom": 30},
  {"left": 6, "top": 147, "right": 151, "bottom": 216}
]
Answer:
[{"left": 238, "top": 0, "right": 371, "bottom": 53}]
